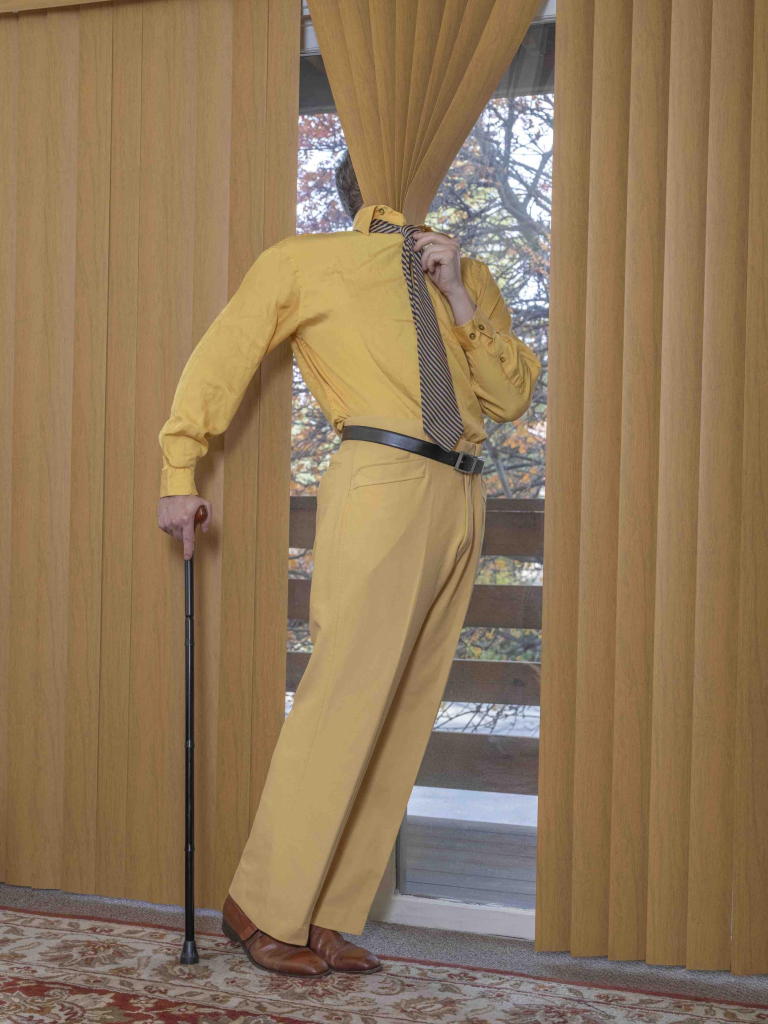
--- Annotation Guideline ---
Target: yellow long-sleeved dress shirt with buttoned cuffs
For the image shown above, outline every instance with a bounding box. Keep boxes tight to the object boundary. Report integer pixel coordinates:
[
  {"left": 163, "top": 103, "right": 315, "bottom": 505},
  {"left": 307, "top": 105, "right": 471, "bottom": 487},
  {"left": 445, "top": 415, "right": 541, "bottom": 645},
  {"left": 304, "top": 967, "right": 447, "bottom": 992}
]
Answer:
[{"left": 159, "top": 206, "right": 542, "bottom": 497}]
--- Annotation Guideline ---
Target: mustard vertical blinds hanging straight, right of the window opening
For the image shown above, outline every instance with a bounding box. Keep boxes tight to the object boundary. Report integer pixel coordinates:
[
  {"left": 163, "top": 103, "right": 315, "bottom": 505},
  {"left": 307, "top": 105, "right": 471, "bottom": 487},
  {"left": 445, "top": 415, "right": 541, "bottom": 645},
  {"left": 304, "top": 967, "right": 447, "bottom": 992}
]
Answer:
[{"left": 536, "top": 0, "right": 768, "bottom": 975}]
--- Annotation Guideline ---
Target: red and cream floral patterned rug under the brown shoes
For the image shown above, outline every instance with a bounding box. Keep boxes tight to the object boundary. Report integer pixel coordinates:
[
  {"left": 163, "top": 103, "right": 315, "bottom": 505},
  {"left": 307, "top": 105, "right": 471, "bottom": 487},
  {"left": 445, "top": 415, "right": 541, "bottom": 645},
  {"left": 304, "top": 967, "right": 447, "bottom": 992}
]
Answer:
[{"left": 0, "top": 908, "right": 768, "bottom": 1024}]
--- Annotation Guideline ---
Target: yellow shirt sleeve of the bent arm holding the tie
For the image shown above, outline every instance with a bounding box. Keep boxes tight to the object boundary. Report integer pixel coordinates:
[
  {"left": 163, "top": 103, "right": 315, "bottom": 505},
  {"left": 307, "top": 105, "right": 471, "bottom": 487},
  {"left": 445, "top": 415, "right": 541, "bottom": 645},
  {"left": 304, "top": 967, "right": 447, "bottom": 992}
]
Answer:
[{"left": 453, "top": 259, "right": 542, "bottom": 423}]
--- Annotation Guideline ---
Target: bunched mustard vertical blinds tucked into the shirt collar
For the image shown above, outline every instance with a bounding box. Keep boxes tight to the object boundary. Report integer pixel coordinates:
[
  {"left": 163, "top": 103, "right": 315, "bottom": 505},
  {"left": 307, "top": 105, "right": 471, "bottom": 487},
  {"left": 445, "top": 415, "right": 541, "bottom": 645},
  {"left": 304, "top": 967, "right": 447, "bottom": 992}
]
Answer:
[{"left": 309, "top": 0, "right": 539, "bottom": 223}]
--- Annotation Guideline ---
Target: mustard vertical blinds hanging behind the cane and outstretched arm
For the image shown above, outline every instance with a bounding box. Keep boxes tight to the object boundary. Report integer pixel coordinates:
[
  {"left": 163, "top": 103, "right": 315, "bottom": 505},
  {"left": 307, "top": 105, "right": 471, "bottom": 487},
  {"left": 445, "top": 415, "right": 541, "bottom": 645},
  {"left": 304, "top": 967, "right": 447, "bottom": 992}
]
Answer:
[{"left": 0, "top": 0, "right": 300, "bottom": 907}]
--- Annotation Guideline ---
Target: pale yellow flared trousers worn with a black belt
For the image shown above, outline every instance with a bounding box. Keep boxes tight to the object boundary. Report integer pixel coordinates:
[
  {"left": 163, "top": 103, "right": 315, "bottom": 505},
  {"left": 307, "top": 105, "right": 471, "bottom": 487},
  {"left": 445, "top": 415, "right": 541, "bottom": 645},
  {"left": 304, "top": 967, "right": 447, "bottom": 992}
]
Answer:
[{"left": 229, "top": 416, "right": 486, "bottom": 944}]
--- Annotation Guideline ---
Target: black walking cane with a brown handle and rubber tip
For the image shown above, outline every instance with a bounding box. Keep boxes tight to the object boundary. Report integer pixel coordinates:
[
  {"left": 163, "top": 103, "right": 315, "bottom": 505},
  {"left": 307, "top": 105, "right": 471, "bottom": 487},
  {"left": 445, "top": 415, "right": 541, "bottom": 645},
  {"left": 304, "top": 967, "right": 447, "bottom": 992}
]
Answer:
[{"left": 179, "top": 505, "right": 208, "bottom": 964}]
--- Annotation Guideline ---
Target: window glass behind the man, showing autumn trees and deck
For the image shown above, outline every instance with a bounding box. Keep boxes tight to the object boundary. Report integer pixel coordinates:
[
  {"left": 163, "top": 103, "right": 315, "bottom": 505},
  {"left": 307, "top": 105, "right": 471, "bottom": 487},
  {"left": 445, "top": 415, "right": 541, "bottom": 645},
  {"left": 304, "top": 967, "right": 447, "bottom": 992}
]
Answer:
[{"left": 287, "top": 4, "right": 555, "bottom": 908}]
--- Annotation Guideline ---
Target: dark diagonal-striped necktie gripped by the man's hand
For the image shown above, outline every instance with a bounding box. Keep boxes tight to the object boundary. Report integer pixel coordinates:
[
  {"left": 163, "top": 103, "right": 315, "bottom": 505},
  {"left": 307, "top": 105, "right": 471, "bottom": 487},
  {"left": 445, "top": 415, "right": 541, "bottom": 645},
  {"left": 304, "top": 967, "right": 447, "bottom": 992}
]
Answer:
[{"left": 370, "top": 217, "right": 464, "bottom": 452}]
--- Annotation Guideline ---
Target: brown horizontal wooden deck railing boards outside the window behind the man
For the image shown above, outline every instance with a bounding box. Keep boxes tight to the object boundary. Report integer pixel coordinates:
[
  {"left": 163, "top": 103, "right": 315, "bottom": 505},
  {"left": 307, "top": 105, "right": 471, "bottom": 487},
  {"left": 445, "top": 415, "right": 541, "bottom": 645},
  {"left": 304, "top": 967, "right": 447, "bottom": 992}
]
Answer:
[{"left": 287, "top": 498, "right": 544, "bottom": 794}]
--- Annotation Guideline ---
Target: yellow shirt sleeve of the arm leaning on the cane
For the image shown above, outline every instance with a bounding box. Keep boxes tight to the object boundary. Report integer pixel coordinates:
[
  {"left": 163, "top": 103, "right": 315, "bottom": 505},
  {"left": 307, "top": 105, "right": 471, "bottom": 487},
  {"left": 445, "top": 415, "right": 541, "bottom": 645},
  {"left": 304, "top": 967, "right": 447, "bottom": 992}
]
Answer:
[{"left": 158, "top": 240, "right": 300, "bottom": 498}]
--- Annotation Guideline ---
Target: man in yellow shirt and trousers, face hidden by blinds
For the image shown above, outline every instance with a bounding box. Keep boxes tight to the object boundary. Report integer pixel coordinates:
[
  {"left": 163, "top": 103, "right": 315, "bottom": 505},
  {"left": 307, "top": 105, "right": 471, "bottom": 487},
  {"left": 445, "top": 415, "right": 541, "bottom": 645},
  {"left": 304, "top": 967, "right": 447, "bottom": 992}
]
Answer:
[{"left": 158, "top": 153, "right": 541, "bottom": 977}]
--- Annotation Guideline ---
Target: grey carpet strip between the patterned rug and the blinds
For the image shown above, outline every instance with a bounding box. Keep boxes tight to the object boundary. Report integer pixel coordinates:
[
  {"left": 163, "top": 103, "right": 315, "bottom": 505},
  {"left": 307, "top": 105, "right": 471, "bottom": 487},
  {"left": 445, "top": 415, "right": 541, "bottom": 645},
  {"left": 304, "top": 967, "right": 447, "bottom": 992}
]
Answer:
[{"left": 0, "top": 884, "right": 768, "bottom": 1004}]
